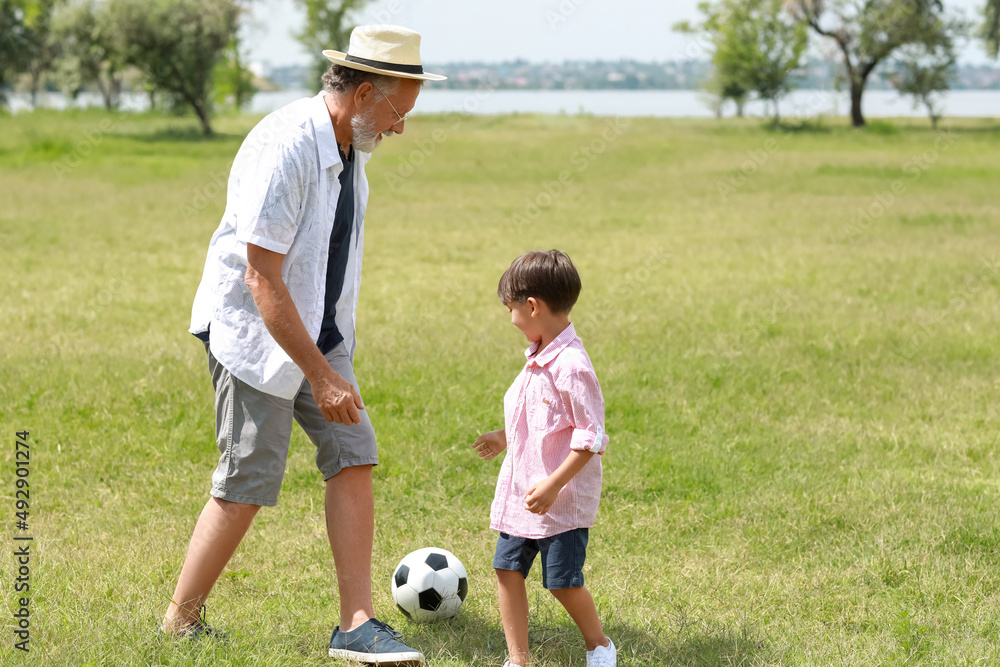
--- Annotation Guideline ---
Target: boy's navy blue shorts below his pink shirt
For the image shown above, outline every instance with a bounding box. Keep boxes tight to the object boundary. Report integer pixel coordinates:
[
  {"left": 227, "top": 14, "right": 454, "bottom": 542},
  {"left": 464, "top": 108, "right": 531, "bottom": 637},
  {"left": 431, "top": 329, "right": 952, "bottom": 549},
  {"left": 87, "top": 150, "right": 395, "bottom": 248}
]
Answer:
[{"left": 493, "top": 528, "right": 590, "bottom": 591}]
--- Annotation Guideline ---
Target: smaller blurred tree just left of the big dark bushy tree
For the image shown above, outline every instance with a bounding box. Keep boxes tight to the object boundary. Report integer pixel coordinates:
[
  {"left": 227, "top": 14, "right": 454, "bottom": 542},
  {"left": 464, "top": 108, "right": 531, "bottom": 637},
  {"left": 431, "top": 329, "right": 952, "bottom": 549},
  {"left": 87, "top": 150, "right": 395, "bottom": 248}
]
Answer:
[{"left": 52, "top": 0, "right": 126, "bottom": 111}]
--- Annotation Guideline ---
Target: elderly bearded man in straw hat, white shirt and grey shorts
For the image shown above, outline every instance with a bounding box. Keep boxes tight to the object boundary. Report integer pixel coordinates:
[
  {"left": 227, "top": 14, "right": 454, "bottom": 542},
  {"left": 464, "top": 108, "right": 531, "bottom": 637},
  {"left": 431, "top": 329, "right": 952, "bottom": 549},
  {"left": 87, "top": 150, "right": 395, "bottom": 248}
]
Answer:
[{"left": 163, "top": 26, "right": 444, "bottom": 664}]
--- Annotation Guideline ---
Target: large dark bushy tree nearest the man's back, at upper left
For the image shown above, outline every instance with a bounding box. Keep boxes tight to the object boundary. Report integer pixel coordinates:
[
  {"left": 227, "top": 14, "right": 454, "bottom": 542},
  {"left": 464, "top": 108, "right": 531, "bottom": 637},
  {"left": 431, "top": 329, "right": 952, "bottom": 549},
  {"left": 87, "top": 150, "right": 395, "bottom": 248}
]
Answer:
[{"left": 109, "top": 0, "right": 241, "bottom": 135}]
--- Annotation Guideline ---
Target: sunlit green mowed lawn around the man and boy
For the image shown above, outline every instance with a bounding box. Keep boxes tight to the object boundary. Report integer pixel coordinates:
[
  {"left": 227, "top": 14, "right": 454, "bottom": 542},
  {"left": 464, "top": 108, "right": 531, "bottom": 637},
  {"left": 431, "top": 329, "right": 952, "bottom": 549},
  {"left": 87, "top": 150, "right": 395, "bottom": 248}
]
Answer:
[{"left": 0, "top": 105, "right": 1000, "bottom": 667}]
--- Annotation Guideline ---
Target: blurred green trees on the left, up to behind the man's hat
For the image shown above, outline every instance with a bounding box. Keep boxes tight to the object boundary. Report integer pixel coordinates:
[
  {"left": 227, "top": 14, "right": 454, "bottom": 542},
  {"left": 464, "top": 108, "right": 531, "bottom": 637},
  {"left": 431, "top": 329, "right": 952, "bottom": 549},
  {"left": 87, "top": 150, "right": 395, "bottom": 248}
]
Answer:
[{"left": 0, "top": 0, "right": 368, "bottom": 134}]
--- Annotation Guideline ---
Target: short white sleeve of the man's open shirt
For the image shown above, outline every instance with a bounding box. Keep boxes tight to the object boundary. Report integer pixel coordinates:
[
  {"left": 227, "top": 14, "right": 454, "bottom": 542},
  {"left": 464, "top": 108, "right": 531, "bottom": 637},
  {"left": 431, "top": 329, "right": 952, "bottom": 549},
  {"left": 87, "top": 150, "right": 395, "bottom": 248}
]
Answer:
[{"left": 236, "top": 143, "right": 307, "bottom": 255}]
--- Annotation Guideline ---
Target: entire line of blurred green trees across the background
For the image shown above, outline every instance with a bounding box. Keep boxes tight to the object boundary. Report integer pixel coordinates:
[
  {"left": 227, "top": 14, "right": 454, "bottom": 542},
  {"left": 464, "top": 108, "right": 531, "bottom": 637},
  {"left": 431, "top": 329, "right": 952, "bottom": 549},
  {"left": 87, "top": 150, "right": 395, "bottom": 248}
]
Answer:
[{"left": 0, "top": 0, "right": 1000, "bottom": 134}]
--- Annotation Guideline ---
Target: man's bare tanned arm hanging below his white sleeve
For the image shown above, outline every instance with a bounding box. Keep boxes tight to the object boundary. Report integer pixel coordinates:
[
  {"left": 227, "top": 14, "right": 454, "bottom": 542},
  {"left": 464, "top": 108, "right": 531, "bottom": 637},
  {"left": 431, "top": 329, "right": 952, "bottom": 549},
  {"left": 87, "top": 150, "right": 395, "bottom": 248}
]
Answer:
[{"left": 245, "top": 243, "right": 365, "bottom": 424}]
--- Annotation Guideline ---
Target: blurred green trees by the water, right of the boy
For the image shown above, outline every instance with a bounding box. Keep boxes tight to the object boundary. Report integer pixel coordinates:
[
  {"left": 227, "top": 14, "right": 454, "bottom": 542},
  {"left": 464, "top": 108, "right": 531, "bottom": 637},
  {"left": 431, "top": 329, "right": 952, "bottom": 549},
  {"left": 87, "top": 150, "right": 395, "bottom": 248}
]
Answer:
[{"left": 674, "top": 0, "right": 1000, "bottom": 127}]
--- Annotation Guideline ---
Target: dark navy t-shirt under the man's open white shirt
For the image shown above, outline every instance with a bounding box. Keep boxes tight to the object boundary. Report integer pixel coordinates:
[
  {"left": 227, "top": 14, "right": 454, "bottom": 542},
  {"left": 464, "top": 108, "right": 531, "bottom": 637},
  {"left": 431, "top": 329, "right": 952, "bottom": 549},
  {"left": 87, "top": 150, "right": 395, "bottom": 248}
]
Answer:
[{"left": 316, "top": 146, "right": 354, "bottom": 354}]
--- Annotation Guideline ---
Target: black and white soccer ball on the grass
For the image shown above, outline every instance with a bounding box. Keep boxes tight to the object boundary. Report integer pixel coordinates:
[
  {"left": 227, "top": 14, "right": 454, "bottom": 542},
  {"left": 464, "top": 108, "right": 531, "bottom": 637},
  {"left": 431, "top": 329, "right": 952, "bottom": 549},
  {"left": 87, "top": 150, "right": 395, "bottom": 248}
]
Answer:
[{"left": 392, "top": 547, "right": 469, "bottom": 623}]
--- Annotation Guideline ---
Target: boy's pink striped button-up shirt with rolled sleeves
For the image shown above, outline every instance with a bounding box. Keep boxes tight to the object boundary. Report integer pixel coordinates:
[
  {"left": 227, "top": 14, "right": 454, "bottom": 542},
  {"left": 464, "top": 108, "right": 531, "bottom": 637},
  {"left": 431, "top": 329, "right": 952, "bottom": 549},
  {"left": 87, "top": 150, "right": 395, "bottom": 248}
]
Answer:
[{"left": 490, "top": 324, "right": 608, "bottom": 539}]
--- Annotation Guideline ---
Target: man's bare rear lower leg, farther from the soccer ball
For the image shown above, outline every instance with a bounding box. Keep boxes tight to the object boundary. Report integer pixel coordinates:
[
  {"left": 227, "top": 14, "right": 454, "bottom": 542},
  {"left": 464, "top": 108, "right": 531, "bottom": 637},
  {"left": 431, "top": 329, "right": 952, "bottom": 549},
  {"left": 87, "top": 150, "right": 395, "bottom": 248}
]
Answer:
[{"left": 163, "top": 498, "right": 260, "bottom": 632}]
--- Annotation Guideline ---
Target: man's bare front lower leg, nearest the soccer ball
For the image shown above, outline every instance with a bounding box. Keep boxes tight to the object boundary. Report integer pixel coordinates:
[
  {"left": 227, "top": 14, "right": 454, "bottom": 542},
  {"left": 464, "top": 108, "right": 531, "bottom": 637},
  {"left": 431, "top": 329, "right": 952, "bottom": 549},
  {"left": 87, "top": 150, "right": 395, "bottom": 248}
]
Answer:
[{"left": 326, "top": 465, "right": 375, "bottom": 632}]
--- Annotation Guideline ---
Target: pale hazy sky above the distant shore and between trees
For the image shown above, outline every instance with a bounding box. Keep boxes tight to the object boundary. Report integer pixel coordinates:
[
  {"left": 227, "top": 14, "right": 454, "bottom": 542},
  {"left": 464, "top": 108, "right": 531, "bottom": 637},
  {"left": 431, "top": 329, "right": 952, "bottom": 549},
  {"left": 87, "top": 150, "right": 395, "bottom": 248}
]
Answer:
[{"left": 246, "top": 0, "right": 987, "bottom": 65}]
